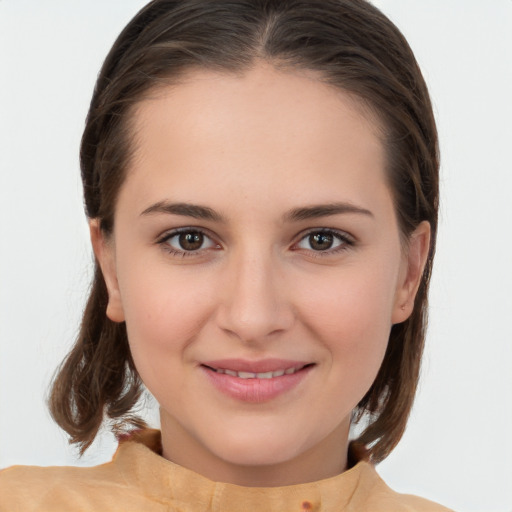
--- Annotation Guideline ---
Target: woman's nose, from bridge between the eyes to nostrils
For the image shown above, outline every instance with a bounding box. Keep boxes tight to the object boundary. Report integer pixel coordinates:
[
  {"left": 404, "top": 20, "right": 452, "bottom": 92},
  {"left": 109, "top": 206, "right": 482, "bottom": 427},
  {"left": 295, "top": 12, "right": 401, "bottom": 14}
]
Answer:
[{"left": 217, "top": 250, "right": 295, "bottom": 343}]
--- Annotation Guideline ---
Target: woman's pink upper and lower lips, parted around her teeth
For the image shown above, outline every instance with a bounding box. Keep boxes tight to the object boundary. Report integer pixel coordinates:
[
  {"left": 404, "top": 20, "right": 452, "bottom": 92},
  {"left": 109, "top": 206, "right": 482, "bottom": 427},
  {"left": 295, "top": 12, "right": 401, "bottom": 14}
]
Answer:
[{"left": 200, "top": 359, "right": 314, "bottom": 403}]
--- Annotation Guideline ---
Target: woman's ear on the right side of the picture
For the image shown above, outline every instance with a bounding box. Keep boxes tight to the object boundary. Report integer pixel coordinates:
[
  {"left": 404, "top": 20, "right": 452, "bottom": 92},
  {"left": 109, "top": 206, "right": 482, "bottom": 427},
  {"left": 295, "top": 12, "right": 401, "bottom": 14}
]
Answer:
[{"left": 392, "top": 220, "right": 430, "bottom": 324}]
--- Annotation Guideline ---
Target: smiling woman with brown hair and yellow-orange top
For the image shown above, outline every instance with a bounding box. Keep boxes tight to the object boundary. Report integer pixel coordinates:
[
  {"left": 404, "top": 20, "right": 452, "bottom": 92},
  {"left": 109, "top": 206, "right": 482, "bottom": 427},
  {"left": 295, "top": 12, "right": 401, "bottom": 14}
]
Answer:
[{"left": 0, "top": 0, "right": 452, "bottom": 510}]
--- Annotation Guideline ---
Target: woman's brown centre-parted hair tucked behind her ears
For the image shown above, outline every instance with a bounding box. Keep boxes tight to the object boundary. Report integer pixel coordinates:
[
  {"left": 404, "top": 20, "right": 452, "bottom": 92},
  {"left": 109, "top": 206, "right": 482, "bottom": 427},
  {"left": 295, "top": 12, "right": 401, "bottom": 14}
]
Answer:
[{"left": 49, "top": 0, "right": 439, "bottom": 462}]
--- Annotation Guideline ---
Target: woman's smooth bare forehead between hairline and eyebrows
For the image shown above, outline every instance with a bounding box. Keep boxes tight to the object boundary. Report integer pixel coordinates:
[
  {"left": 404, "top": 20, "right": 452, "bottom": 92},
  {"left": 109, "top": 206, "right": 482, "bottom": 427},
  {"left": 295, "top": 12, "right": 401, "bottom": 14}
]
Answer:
[{"left": 121, "top": 64, "right": 385, "bottom": 216}]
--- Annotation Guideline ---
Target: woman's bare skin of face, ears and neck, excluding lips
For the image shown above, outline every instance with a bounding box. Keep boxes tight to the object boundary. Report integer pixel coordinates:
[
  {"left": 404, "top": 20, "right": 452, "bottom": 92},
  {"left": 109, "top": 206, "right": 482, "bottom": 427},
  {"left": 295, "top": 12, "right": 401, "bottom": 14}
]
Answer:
[{"left": 91, "top": 64, "right": 430, "bottom": 486}]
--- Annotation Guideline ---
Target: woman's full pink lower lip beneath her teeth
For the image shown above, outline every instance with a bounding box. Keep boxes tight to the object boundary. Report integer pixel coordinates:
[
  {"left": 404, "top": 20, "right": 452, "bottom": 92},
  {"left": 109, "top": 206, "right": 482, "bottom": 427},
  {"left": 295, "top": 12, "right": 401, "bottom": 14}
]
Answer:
[{"left": 201, "top": 366, "right": 313, "bottom": 403}]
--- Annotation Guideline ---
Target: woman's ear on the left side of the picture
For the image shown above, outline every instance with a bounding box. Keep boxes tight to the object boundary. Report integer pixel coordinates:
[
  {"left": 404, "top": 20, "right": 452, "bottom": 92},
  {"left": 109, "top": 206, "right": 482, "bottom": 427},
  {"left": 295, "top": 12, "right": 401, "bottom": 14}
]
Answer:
[{"left": 89, "top": 219, "right": 124, "bottom": 322}]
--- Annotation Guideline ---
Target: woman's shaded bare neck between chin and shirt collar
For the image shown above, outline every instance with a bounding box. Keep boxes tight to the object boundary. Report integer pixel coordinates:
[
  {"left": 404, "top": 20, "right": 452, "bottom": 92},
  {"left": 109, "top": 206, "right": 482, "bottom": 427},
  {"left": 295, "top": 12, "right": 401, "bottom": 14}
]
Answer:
[{"left": 161, "top": 415, "right": 349, "bottom": 487}]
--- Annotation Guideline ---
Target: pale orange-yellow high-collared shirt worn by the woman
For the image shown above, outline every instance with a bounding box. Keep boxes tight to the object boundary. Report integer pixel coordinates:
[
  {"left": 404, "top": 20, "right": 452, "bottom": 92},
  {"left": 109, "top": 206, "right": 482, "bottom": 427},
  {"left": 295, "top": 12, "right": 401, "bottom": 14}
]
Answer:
[{"left": 0, "top": 430, "right": 448, "bottom": 512}]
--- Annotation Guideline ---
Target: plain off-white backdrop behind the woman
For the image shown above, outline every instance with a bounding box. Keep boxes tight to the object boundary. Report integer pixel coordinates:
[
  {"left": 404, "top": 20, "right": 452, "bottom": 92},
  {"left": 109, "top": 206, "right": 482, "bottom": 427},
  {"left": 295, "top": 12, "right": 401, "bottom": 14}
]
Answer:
[{"left": 0, "top": 0, "right": 512, "bottom": 512}]
